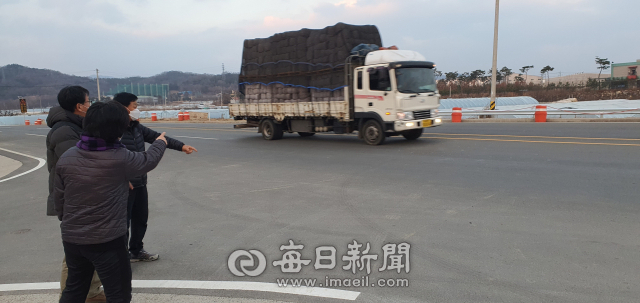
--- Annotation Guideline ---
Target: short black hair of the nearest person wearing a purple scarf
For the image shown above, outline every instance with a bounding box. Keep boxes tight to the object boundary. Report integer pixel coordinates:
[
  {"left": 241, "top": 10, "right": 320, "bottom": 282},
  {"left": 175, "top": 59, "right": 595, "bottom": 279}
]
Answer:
[{"left": 82, "top": 101, "right": 130, "bottom": 143}]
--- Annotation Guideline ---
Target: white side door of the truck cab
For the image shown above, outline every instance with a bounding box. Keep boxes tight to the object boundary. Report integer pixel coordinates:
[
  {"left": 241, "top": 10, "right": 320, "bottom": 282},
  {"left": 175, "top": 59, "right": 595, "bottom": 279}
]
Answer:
[{"left": 354, "top": 65, "right": 395, "bottom": 121}]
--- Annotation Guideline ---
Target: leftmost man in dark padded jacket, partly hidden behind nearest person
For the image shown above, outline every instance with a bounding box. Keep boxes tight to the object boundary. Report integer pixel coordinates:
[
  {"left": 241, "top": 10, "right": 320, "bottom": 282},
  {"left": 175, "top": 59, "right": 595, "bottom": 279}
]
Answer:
[{"left": 46, "top": 86, "right": 106, "bottom": 302}]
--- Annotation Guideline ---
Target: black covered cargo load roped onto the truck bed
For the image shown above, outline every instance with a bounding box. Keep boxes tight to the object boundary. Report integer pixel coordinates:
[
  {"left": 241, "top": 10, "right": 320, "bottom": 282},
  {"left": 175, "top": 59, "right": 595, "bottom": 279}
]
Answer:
[{"left": 239, "top": 23, "right": 382, "bottom": 102}]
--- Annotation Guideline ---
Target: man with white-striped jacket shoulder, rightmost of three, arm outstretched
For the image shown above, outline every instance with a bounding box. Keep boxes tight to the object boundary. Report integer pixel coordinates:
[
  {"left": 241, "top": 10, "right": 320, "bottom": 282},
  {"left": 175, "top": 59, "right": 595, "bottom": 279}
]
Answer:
[{"left": 113, "top": 93, "right": 197, "bottom": 262}]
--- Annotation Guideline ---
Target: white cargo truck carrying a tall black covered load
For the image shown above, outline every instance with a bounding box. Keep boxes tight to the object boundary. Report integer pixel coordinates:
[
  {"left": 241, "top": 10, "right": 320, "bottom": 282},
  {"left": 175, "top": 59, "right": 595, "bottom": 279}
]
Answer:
[{"left": 229, "top": 23, "right": 442, "bottom": 145}]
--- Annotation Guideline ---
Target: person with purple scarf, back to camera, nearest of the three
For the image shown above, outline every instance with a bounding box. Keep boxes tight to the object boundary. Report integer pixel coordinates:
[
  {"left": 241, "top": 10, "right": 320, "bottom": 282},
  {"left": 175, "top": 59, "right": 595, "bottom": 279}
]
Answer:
[{"left": 53, "top": 101, "right": 167, "bottom": 303}]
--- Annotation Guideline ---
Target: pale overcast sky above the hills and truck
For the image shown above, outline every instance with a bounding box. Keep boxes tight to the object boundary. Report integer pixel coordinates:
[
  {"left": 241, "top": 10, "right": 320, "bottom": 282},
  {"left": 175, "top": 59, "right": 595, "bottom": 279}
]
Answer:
[{"left": 0, "top": 0, "right": 640, "bottom": 77}]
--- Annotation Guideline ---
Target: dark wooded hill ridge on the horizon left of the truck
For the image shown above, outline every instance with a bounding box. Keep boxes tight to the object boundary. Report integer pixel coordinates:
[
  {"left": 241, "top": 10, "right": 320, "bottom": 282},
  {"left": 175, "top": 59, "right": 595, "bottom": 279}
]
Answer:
[{"left": 0, "top": 64, "right": 238, "bottom": 109}]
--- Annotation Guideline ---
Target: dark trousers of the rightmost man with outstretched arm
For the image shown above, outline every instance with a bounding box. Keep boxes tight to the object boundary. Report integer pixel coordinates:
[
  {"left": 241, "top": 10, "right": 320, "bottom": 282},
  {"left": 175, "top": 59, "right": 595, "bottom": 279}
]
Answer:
[{"left": 127, "top": 186, "right": 149, "bottom": 255}]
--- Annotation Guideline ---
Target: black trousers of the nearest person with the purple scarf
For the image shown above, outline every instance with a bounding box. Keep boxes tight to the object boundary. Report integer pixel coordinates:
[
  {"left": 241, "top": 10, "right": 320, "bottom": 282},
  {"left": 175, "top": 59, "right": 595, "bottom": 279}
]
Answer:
[{"left": 60, "top": 236, "right": 131, "bottom": 303}]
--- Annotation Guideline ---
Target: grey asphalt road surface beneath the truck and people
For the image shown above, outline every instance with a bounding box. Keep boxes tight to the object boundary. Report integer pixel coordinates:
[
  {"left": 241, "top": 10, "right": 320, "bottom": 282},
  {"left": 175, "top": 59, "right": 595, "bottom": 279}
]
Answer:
[{"left": 0, "top": 123, "right": 640, "bottom": 302}]
